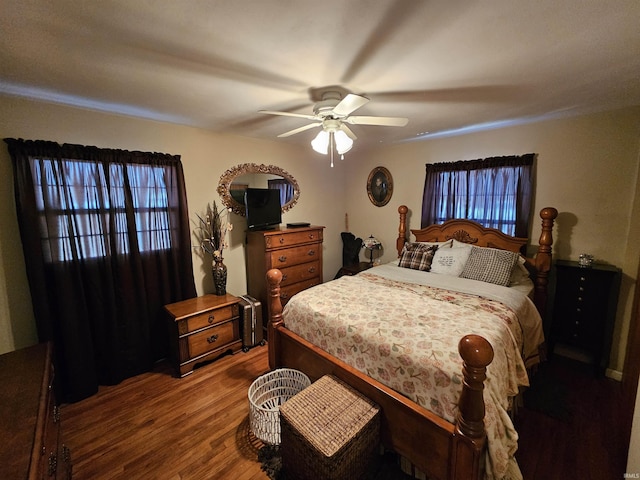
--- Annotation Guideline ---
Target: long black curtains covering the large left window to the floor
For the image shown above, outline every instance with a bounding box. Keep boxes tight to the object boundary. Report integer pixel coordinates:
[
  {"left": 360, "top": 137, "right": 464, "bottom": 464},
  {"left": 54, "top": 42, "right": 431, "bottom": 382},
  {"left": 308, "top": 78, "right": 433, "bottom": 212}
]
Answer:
[{"left": 5, "top": 139, "right": 196, "bottom": 402}]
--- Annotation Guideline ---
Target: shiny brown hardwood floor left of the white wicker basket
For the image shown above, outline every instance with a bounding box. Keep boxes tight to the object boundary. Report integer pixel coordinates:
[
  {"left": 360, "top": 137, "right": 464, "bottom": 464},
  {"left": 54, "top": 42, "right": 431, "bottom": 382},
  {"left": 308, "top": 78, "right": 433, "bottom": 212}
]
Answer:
[{"left": 62, "top": 346, "right": 269, "bottom": 480}]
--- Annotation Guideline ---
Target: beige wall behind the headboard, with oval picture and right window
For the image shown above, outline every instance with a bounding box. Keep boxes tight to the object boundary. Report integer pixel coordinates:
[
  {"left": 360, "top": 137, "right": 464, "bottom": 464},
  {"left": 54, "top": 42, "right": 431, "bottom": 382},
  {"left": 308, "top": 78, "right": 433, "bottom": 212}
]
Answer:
[{"left": 346, "top": 108, "right": 640, "bottom": 376}]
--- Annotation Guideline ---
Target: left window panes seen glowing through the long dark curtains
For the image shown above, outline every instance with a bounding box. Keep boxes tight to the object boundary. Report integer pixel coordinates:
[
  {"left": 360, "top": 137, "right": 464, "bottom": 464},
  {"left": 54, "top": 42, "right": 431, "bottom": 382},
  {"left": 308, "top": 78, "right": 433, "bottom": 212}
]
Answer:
[{"left": 30, "top": 157, "right": 171, "bottom": 262}]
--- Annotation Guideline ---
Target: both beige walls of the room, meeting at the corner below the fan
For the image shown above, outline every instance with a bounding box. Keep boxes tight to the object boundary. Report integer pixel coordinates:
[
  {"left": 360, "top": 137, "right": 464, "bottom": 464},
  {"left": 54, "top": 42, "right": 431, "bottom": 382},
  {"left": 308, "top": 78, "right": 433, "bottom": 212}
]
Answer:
[{"left": 0, "top": 96, "right": 640, "bottom": 371}]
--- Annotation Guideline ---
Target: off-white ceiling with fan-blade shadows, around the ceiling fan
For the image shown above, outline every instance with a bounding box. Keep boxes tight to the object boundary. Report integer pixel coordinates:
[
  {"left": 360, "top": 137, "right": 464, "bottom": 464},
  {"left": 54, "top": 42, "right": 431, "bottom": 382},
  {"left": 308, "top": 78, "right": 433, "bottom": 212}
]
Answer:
[{"left": 0, "top": 0, "right": 640, "bottom": 146}]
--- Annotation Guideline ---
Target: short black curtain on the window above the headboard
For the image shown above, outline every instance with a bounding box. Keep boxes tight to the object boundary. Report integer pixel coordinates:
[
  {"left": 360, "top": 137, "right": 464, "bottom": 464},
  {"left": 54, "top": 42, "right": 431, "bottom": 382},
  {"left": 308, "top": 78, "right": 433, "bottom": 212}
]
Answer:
[{"left": 422, "top": 153, "right": 535, "bottom": 237}]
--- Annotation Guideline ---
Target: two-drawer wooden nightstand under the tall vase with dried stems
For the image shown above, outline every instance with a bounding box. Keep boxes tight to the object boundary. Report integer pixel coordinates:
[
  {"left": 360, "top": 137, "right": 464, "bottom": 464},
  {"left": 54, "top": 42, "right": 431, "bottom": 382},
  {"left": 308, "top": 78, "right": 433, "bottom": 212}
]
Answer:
[{"left": 164, "top": 294, "right": 242, "bottom": 377}]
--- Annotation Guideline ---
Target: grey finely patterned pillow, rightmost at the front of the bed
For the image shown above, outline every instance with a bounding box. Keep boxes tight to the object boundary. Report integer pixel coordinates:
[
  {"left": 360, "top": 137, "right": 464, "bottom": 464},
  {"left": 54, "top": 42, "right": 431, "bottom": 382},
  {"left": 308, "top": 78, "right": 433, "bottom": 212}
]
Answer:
[{"left": 460, "top": 246, "right": 519, "bottom": 287}]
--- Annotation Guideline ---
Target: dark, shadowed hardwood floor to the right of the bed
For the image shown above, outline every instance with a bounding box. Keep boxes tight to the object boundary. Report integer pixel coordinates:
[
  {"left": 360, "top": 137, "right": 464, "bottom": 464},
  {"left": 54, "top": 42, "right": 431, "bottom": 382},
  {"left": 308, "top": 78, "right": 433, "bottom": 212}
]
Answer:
[{"left": 514, "top": 356, "right": 628, "bottom": 480}]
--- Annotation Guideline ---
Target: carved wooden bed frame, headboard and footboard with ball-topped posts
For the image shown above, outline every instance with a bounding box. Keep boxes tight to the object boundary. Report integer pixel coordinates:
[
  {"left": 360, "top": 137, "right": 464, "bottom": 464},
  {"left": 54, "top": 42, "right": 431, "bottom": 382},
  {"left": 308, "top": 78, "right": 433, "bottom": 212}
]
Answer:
[{"left": 267, "top": 205, "right": 558, "bottom": 480}]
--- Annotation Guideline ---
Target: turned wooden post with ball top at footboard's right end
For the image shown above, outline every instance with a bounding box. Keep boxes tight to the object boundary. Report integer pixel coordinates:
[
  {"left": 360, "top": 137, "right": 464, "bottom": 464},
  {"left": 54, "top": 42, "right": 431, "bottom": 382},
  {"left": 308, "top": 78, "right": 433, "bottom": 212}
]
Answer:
[{"left": 456, "top": 335, "right": 493, "bottom": 438}]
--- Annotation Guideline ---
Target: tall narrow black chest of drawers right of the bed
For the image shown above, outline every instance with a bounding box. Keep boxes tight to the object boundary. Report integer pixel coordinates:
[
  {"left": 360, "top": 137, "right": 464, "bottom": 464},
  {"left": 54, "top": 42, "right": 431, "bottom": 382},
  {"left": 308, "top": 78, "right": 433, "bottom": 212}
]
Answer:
[{"left": 550, "top": 260, "right": 622, "bottom": 375}]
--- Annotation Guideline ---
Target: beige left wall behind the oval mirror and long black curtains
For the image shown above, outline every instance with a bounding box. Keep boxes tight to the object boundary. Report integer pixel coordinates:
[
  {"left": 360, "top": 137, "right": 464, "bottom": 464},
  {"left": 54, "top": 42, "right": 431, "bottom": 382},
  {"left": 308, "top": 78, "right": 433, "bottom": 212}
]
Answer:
[{"left": 0, "top": 96, "right": 346, "bottom": 353}]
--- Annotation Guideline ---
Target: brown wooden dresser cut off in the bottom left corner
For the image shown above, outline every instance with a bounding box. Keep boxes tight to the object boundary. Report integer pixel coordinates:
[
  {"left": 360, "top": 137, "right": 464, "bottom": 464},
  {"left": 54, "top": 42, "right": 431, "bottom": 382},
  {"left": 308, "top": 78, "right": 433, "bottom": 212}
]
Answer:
[{"left": 0, "top": 343, "right": 71, "bottom": 480}]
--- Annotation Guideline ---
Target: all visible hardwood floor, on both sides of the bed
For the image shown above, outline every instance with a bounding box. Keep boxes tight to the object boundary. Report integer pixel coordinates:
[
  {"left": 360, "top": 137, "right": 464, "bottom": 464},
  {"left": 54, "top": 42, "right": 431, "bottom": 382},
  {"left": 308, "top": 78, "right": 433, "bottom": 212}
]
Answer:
[{"left": 62, "top": 346, "right": 626, "bottom": 480}]
